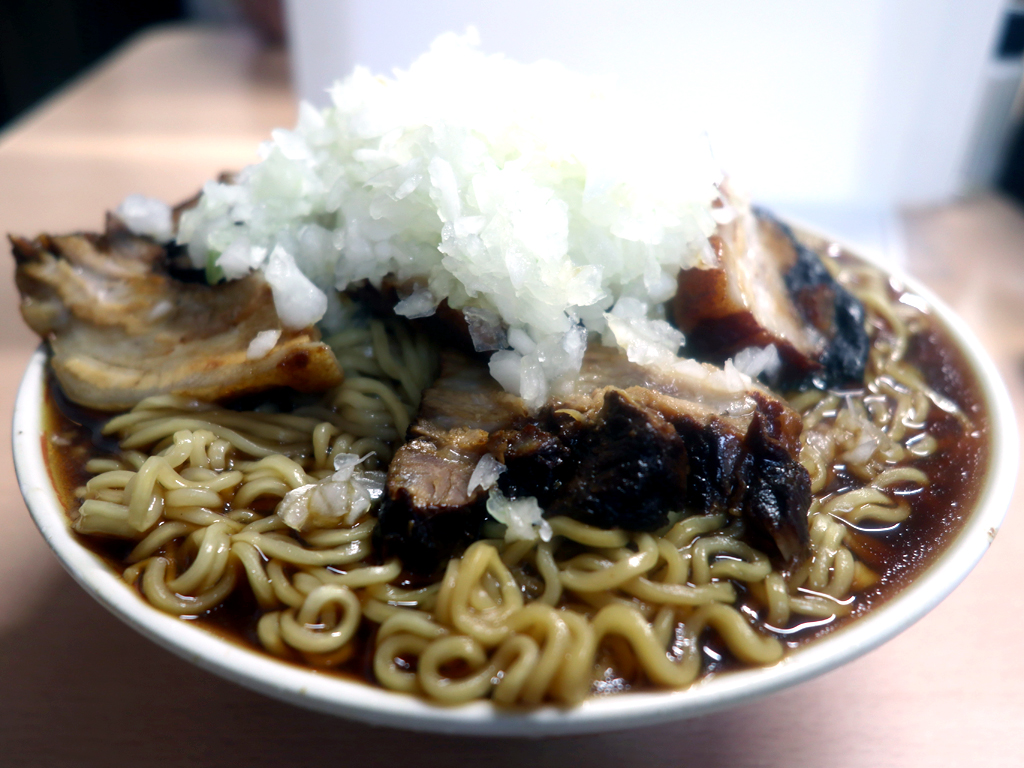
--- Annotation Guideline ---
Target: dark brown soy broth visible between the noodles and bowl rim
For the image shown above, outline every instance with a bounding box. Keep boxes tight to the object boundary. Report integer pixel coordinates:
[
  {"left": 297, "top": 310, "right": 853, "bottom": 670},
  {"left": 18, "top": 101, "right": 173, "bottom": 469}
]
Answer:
[{"left": 43, "top": 280, "right": 991, "bottom": 693}]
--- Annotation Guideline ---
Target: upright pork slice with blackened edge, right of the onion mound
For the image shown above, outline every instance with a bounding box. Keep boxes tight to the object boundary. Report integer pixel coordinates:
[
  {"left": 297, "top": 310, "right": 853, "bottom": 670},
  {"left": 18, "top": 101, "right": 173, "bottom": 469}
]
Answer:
[{"left": 674, "top": 199, "right": 868, "bottom": 387}]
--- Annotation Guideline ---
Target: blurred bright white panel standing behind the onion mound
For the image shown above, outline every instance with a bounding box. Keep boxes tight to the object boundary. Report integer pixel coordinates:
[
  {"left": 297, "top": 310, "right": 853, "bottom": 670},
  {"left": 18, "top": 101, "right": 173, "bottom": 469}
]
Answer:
[{"left": 287, "top": 0, "right": 1007, "bottom": 260}]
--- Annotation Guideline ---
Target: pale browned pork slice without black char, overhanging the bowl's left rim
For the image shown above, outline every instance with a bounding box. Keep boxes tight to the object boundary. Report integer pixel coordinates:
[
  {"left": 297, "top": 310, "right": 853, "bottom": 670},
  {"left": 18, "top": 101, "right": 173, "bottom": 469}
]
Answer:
[{"left": 10, "top": 227, "right": 342, "bottom": 411}]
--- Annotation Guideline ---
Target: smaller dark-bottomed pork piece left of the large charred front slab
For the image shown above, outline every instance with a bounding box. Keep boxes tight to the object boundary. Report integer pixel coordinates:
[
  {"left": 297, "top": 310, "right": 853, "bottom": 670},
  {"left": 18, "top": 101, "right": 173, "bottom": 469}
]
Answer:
[{"left": 377, "top": 351, "right": 527, "bottom": 573}]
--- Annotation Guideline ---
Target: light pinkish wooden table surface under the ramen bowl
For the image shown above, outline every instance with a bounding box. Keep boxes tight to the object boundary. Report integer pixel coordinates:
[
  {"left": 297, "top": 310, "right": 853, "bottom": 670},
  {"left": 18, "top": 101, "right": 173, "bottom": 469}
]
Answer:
[{"left": 0, "top": 28, "right": 1024, "bottom": 768}]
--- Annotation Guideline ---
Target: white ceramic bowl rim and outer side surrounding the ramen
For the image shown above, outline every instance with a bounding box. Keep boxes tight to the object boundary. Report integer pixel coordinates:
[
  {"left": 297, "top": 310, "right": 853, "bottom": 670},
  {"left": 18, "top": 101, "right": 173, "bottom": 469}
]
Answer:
[{"left": 13, "top": 268, "right": 1018, "bottom": 736}]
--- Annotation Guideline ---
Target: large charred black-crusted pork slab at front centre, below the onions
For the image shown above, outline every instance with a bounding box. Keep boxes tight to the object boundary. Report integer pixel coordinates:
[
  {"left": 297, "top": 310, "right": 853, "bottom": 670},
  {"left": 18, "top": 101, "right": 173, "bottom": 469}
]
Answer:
[{"left": 489, "top": 347, "right": 811, "bottom": 562}]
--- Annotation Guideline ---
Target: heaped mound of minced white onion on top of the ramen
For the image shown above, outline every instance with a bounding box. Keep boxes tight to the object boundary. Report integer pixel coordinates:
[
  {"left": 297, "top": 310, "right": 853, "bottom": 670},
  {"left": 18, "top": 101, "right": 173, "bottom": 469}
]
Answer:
[{"left": 178, "top": 32, "right": 721, "bottom": 404}]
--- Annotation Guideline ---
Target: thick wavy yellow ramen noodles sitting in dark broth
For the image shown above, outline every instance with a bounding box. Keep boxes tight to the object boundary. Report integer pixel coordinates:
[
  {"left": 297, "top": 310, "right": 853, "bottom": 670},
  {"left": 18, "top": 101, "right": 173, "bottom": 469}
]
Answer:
[{"left": 56, "top": 250, "right": 976, "bottom": 706}]
